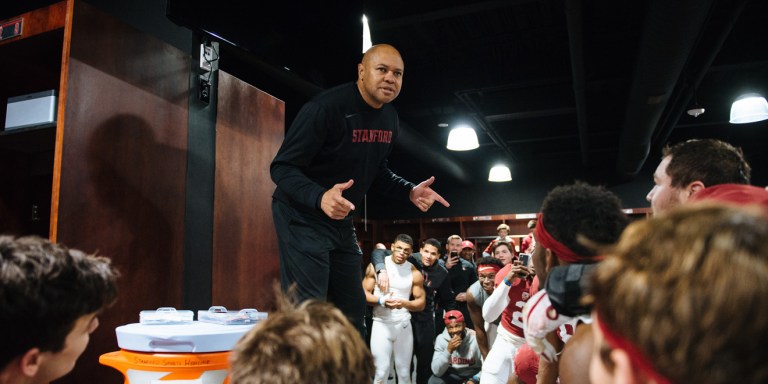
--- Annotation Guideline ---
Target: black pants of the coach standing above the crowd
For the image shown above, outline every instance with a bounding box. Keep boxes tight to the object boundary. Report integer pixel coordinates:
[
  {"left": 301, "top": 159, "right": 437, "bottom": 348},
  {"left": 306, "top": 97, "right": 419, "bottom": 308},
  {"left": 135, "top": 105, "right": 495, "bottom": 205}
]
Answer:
[{"left": 272, "top": 199, "right": 365, "bottom": 340}]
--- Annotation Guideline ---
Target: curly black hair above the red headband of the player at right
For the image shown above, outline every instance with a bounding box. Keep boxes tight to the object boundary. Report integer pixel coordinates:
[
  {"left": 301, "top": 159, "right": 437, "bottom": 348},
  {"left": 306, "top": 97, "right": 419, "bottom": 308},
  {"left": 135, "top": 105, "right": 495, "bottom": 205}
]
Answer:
[{"left": 541, "top": 182, "right": 629, "bottom": 257}]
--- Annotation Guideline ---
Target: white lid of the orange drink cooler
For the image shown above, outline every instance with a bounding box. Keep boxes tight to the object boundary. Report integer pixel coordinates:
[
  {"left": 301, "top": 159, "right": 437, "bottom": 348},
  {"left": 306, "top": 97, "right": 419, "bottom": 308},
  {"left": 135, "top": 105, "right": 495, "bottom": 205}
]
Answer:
[{"left": 115, "top": 321, "right": 254, "bottom": 353}]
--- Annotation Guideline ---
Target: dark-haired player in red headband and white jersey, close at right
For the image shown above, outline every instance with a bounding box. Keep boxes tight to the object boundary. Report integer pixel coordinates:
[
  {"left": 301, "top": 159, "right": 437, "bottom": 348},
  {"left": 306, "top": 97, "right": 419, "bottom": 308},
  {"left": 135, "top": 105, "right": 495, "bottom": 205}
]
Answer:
[{"left": 523, "top": 183, "right": 628, "bottom": 383}]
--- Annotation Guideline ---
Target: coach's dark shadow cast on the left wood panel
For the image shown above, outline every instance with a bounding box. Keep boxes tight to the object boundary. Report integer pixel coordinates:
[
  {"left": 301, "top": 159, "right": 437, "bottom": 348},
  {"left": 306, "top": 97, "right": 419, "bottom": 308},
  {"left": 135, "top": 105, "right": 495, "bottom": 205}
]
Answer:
[{"left": 58, "top": 114, "right": 186, "bottom": 383}]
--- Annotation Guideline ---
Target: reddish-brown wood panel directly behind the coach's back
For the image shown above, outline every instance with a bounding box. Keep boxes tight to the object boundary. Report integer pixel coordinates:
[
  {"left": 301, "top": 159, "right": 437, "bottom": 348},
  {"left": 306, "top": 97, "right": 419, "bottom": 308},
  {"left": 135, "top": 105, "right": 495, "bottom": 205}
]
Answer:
[{"left": 213, "top": 71, "right": 285, "bottom": 310}]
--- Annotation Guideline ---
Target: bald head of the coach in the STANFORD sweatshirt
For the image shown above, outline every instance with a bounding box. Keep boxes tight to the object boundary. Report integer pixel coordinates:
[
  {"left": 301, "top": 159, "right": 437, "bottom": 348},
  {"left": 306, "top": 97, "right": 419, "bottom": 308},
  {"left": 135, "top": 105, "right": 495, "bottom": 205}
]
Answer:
[{"left": 357, "top": 44, "right": 405, "bottom": 109}]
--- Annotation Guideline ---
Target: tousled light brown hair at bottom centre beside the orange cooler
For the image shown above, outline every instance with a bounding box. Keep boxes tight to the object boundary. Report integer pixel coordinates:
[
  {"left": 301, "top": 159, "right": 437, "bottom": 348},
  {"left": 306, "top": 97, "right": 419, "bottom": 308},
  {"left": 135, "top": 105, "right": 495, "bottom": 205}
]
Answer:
[{"left": 231, "top": 295, "right": 374, "bottom": 384}]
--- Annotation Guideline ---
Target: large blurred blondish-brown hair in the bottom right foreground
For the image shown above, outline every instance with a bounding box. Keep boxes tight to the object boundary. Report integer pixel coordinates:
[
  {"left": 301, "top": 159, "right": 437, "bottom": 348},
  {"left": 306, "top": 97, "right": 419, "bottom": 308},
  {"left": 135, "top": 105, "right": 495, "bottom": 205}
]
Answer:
[{"left": 592, "top": 203, "right": 768, "bottom": 384}]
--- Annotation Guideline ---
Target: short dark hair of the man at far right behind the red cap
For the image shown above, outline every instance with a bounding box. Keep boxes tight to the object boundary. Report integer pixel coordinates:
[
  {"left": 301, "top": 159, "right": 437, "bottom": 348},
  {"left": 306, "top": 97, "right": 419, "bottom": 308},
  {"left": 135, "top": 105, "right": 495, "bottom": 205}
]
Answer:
[{"left": 662, "top": 139, "right": 752, "bottom": 188}]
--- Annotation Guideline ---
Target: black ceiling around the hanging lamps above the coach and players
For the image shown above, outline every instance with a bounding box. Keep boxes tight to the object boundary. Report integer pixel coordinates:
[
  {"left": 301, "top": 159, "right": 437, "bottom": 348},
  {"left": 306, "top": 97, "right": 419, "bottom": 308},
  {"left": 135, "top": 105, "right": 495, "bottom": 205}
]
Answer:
[{"left": 6, "top": 0, "right": 768, "bottom": 188}]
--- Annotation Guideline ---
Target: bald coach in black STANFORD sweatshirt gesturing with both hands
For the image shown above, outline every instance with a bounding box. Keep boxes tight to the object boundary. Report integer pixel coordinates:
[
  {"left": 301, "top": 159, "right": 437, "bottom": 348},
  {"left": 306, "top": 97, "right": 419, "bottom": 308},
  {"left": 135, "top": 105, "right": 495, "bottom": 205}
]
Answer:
[{"left": 270, "top": 44, "right": 448, "bottom": 334}]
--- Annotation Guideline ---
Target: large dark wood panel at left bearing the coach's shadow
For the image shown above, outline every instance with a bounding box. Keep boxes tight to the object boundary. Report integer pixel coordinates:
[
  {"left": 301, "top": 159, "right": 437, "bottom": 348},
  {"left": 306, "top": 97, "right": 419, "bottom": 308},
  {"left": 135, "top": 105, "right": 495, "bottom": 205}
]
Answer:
[{"left": 57, "top": 3, "right": 191, "bottom": 383}]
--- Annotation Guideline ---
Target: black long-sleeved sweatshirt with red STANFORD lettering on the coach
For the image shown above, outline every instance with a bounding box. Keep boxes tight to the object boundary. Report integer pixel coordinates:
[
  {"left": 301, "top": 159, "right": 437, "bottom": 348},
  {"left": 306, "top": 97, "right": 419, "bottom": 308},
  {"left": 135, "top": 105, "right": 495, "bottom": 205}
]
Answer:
[{"left": 270, "top": 83, "right": 415, "bottom": 220}]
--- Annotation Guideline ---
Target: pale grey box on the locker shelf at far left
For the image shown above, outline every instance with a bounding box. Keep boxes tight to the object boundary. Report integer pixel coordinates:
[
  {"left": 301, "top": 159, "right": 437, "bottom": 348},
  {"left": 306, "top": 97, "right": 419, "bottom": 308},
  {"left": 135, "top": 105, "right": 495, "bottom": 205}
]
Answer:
[{"left": 5, "top": 89, "right": 56, "bottom": 131}]
